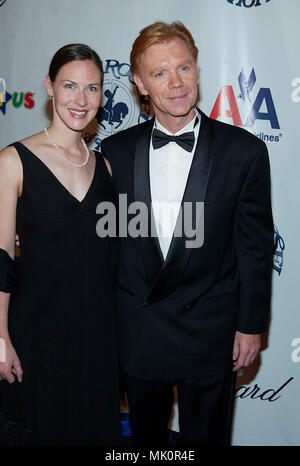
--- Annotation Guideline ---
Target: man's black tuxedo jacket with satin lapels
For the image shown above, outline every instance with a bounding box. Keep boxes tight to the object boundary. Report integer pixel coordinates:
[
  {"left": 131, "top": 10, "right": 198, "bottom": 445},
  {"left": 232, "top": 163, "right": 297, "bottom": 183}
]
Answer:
[{"left": 102, "top": 112, "right": 273, "bottom": 381}]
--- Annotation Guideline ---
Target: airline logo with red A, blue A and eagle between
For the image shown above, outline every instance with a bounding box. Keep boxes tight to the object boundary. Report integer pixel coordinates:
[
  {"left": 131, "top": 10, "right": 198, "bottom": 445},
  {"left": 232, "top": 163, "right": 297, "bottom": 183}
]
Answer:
[{"left": 210, "top": 68, "right": 282, "bottom": 142}]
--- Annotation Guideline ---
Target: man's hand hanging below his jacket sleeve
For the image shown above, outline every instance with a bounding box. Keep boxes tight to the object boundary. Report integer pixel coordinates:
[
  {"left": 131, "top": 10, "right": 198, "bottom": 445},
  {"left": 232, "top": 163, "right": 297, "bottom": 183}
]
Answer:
[{"left": 232, "top": 331, "right": 260, "bottom": 372}]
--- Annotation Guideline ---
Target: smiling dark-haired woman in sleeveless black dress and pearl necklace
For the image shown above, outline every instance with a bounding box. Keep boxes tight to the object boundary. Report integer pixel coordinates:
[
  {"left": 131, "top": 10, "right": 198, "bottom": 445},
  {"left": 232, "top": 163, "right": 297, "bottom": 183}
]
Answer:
[{"left": 0, "top": 44, "right": 120, "bottom": 445}]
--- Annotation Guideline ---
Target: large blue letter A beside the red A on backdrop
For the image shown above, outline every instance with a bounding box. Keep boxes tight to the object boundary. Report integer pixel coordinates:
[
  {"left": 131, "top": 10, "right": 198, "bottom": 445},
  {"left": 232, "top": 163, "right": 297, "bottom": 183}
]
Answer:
[{"left": 245, "top": 87, "right": 280, "bottom": 129}]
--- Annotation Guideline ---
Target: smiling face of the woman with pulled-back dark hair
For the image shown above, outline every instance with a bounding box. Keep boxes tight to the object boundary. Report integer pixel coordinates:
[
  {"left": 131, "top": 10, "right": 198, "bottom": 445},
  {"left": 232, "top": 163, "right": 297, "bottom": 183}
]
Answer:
[{"left": 45, "top": 60, "right": 101, "bottom": 131}]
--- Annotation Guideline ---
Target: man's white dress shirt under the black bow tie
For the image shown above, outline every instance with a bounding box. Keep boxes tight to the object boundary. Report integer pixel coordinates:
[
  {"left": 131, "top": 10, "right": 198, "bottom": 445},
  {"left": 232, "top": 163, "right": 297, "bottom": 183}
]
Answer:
[{"left": 149, "top": 109, "right": 201, "bottom": 259}]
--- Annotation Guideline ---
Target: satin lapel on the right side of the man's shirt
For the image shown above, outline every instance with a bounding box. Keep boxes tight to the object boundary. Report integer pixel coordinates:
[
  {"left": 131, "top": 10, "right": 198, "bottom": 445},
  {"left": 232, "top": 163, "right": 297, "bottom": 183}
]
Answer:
[{"left": 147, "top": 112, "right": 214, "bottom": 304}]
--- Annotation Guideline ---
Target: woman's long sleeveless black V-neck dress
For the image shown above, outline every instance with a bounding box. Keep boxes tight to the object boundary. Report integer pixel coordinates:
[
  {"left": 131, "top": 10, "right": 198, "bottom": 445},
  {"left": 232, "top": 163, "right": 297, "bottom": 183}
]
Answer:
[{"left": 0, "top": 142, "right": 120, "bottom": 445}]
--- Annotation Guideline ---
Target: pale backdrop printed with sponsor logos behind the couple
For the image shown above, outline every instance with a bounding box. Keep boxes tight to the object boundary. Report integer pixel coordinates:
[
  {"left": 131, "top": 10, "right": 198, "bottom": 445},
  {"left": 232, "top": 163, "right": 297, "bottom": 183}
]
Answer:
[{"left": 0, "top": 0, "right": 300, "bottom": 446}]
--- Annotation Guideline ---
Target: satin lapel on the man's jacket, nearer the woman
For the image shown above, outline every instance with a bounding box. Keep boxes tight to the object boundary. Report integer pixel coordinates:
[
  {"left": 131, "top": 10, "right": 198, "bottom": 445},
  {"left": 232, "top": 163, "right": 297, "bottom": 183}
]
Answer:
[{"left": 133, "top": 119, "right": 163, "bottom": 286}]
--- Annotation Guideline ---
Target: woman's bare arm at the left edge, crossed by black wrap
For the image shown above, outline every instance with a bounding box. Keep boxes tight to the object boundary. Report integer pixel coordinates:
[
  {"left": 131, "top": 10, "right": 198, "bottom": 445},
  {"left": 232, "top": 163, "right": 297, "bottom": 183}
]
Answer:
[{"left": 0, "top": 147, "right": 23, "bottom": 383}]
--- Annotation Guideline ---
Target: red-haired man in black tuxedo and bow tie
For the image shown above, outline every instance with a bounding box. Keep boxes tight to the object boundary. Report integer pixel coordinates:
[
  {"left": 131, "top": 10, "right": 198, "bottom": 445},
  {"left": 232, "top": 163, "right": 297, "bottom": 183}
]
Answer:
[{"left": 102, "top": 22, "right": 273, "bottom": 446}]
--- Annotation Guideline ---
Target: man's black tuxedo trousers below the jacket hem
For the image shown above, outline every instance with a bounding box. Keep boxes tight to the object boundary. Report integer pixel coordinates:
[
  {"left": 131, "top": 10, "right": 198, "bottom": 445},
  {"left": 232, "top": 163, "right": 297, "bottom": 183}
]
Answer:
[{"left": 124, "top": 369, "right": 235, "bottom": 447}]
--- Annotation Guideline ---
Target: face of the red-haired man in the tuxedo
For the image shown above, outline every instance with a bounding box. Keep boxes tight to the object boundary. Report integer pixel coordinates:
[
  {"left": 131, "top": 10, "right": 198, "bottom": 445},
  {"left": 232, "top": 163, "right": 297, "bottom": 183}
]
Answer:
[{"left": 134, "top": 39, "right": 199, "bottom": 129}]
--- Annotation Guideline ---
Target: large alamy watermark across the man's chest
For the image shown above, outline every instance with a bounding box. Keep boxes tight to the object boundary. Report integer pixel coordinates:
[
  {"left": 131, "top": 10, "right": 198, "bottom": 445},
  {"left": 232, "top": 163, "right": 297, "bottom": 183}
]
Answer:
[{"left": 96, "top": 194, "right": 204, "bottom": 248}]
